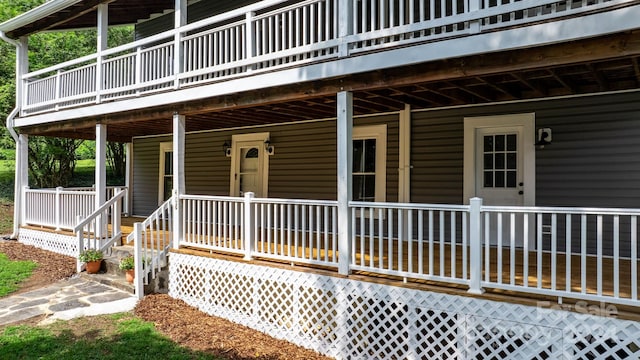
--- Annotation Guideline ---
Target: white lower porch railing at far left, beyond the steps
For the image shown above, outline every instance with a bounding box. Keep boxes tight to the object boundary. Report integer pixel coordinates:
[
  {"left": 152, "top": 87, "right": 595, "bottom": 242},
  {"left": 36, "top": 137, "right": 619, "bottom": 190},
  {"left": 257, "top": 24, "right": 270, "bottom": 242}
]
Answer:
[{"left": 21, "top": 186, "right": 128, "bottom": 230}]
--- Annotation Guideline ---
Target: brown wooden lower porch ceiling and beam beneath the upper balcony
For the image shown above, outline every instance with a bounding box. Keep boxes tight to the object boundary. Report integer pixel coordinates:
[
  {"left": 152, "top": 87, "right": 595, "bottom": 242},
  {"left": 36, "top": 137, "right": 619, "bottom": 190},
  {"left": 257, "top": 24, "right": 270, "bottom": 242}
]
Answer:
[{"left": 21, "top": 32, "right": 640, "bottom": 142}]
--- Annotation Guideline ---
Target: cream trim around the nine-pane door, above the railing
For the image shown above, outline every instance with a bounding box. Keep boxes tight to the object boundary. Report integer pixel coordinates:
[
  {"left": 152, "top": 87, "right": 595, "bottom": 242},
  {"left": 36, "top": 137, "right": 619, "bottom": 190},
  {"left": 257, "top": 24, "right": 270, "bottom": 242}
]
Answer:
[{"left": 463, "top": 113, "right": 536, "bottom": 206}]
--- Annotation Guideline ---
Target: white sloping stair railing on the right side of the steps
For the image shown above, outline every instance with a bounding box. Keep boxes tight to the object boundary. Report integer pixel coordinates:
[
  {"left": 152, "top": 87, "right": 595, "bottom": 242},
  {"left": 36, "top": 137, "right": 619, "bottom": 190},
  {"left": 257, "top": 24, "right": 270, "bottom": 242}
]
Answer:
[{"left": 127, "top": 198, "right": 174, "bottom": 298}]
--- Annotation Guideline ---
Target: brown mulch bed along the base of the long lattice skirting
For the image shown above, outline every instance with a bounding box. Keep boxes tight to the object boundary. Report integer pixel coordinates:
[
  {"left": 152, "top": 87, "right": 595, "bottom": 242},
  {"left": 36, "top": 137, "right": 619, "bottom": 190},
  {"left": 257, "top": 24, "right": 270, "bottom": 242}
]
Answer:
[{"left": 134, "top": 294, "right": 336, "bottom": 360}]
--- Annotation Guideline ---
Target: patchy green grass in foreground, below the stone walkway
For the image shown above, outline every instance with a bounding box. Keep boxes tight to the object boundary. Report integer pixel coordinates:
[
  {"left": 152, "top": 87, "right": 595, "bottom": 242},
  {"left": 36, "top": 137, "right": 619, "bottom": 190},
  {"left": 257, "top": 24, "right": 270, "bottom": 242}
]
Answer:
[{"left": 0, "top": 313, "right": 222, "bottom": 360}]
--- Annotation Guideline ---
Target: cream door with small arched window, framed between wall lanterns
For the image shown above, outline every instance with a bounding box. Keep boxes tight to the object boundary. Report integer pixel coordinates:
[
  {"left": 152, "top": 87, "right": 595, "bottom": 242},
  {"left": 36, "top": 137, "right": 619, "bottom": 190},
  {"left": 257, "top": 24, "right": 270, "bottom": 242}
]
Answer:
[{"left": 230, "top": 133, "right": 269, "bottom": 197}]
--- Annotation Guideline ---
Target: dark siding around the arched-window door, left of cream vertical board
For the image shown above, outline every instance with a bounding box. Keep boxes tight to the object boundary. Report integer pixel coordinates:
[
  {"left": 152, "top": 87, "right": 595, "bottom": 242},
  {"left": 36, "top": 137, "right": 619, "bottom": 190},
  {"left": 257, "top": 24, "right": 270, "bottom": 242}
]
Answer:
[{"left": 133, "top": 114, "right": 398, "bottom": 215}]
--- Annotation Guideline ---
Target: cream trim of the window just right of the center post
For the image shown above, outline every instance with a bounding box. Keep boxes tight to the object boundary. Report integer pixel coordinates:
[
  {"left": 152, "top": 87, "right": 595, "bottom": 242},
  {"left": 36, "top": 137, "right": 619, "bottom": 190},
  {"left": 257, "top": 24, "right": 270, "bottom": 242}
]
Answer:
[{"left": 351, "top": 124, "right": 387, "bottom": 202}]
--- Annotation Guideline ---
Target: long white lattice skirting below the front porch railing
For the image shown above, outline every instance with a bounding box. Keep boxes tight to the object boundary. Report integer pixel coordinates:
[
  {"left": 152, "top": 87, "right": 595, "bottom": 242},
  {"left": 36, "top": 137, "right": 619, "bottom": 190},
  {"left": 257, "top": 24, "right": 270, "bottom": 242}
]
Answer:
[{"left": 169, "top": 253, "right": 640, "bottom": 359}]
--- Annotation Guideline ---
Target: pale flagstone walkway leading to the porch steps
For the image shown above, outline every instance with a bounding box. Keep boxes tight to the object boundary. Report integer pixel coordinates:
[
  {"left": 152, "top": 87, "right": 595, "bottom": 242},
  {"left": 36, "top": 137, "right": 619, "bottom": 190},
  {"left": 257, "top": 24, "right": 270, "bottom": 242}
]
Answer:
[{"left": 0, "top": 276, "right": 138, "bottom": 326}]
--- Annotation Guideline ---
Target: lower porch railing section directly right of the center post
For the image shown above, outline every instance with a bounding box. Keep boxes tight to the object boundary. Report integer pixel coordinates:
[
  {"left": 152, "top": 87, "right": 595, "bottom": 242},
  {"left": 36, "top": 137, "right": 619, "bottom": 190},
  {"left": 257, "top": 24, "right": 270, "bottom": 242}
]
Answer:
[{"left": 349, "top": 202, "right": 469, "bottom": 284}]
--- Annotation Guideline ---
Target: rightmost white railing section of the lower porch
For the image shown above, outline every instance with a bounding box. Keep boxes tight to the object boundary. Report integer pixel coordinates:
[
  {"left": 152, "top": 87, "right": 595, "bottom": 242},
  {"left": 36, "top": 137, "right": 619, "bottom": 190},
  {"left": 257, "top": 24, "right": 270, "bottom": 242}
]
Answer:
[{"left": 481, "top": 206, "right": 640, "bottom": 306}]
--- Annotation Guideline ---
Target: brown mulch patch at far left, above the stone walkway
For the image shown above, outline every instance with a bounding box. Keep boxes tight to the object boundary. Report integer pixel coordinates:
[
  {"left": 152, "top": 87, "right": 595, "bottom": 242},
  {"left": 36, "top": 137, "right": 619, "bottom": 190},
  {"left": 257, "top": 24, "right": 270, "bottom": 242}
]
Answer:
[{"left": 0, "top": 240, "right": 76, "bottom": 294}]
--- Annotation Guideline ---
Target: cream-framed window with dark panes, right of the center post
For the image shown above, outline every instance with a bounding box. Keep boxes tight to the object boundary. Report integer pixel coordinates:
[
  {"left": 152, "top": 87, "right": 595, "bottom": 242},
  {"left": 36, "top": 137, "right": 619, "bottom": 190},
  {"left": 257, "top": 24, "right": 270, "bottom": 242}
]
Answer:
[{"left": 352, "top": 125, "right": 387, "bottom": 202}]
